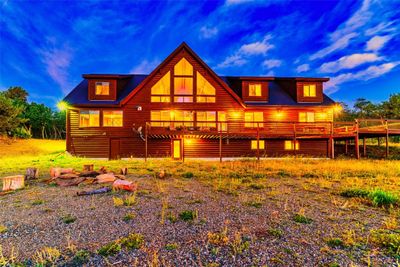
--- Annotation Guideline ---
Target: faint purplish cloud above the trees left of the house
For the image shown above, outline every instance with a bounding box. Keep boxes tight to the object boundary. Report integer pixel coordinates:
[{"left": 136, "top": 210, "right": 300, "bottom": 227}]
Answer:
[{"left": 39, "top": 47, "right": 72, "bottom": 94}]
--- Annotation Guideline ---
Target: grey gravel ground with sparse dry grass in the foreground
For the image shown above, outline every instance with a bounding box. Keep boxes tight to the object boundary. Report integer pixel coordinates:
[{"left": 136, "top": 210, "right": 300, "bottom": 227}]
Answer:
[{"left": 0, "top": 175, "right": 397, "bottom": 266}]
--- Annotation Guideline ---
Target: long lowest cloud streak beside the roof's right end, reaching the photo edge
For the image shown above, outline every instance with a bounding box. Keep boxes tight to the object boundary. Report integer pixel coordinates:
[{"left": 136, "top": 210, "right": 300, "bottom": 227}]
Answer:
[{"left": 325, "top": 61, "right": 400, "bottom": 94}]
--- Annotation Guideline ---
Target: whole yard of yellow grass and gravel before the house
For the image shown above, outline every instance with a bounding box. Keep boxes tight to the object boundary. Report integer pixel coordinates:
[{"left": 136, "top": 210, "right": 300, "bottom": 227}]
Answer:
[{"left": 0, "top": 140, "right": 400, "bottom": 266}]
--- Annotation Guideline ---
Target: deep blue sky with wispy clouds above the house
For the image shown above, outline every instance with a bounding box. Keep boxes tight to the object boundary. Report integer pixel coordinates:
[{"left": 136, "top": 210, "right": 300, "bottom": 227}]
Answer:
[{"left": 0, "top": 0, "right": 400, "bottom": 109}]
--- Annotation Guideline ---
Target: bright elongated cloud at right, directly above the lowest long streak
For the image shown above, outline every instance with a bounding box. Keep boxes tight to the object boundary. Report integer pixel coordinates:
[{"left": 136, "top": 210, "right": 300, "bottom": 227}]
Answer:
[{"left": 319, "top": 53, "right": 383, "bottom": 73}]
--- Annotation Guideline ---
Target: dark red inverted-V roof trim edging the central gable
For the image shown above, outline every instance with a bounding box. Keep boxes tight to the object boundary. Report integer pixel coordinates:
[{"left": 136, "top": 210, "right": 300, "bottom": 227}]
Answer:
[{"left": 121, "top": 42, "right": 245, "bottom": 107}]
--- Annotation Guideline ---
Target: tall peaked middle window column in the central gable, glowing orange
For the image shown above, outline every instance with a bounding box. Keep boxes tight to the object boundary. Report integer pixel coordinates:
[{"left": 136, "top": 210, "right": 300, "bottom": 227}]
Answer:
[{"left": 174, "top": 58, "right": 193, "bottom": 103}]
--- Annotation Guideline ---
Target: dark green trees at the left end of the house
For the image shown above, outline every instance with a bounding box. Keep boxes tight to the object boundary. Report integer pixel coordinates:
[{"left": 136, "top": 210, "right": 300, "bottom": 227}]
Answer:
[{"left": 0, "top": 86, "right": 66, "bottom": 139}]
